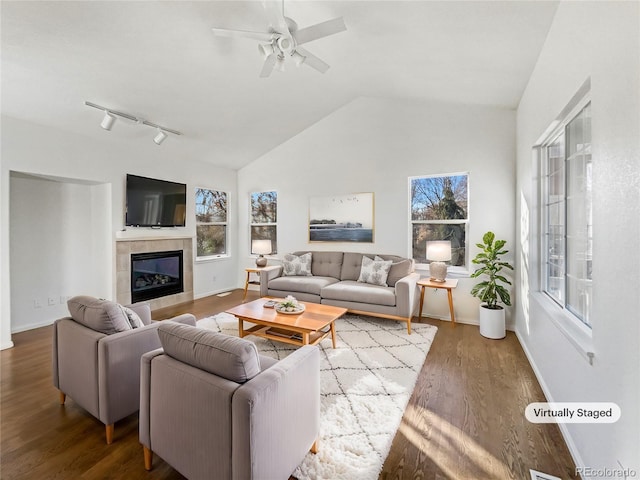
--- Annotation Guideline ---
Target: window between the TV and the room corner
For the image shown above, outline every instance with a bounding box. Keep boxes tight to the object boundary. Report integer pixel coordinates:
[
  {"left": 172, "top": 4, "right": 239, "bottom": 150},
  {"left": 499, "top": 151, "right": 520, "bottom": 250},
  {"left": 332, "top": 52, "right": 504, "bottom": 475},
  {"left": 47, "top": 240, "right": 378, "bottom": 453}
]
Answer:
[{"left": 196, "top": 188, "right": 227, "bottom": 260}]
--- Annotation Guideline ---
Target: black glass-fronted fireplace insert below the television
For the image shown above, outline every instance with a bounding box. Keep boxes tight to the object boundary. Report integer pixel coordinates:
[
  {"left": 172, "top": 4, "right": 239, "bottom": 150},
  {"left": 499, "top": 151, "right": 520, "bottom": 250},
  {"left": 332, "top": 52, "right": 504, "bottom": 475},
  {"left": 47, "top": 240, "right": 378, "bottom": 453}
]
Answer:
[{"left": 131, "top": 250, "right": 184, "bottom": 303}]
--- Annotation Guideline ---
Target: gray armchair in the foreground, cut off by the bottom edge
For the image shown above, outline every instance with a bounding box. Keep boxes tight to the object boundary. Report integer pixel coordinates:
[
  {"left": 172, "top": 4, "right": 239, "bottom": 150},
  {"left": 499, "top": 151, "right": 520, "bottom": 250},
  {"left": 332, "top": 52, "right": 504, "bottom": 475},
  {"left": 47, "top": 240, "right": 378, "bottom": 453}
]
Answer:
[{"left": 140, "top": 324, "right": 320, "bottom": 480}]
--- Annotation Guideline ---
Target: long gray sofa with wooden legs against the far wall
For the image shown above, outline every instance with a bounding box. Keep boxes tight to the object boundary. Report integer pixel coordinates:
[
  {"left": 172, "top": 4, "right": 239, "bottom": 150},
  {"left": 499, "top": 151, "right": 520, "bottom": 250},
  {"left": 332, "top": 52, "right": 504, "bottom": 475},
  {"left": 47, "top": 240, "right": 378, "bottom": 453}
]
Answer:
[{"left": 260, "top": 250, "right": 420, "bottom": 333}]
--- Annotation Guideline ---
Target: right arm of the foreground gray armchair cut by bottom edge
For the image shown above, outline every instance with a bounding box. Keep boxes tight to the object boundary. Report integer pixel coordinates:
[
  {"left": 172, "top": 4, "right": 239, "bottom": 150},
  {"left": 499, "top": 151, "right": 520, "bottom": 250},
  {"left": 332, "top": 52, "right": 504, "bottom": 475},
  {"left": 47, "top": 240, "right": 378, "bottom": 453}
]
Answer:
[{"left": 231, "top": 345, "right": 320, "bottom": 479}]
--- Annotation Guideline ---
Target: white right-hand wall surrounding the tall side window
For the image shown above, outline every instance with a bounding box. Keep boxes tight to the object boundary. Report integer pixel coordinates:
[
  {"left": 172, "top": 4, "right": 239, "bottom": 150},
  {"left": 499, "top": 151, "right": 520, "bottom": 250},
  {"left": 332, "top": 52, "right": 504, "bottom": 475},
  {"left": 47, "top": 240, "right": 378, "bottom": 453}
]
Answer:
[{"left": 516, "top": 2, "right": 640, "bottom": 472}]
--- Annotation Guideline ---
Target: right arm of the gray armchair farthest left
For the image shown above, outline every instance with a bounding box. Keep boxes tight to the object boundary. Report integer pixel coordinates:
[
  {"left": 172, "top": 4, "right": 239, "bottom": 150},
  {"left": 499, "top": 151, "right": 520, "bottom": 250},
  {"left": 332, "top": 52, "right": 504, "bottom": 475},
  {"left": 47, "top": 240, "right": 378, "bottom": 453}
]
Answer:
[{"left": 98, "top": 322, "right": 160, "bottom": 425}]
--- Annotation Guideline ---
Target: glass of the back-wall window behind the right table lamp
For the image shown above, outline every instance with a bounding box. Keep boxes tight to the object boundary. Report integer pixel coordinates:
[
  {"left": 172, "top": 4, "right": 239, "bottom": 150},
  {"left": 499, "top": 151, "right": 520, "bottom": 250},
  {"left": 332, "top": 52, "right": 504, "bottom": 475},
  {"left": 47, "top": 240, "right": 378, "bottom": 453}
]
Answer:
[{"left": 409, "top": 173, "right": 469, "bottom": 271}]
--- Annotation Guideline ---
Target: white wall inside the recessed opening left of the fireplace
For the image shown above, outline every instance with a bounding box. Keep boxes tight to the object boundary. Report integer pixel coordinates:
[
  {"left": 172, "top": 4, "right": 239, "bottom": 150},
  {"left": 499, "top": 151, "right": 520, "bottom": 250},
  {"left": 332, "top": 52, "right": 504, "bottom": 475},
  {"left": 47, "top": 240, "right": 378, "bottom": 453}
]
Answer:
[{"left": 10, "top": 173, "right": 111, "bottom": 332}]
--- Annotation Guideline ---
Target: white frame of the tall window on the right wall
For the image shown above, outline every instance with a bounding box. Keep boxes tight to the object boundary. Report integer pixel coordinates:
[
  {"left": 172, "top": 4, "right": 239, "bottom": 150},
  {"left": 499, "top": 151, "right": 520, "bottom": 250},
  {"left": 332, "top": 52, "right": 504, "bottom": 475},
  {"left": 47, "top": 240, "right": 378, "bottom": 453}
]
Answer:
[{"left": 535, "top": 94, "right": 593, "bottom": 334}]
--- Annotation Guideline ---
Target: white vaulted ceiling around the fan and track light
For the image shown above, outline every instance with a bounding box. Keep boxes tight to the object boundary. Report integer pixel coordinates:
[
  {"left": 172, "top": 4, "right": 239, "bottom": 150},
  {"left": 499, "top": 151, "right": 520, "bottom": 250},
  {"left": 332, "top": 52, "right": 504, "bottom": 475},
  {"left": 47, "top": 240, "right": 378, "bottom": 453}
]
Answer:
[{"left": 1, "top": 0, "right": 558, "bottom": 169}]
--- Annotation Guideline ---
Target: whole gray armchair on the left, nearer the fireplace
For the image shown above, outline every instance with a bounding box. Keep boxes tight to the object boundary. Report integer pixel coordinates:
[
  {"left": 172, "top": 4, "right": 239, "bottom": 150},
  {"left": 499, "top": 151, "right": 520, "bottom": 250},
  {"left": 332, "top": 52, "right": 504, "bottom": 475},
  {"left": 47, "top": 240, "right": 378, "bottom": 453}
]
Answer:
[{"left": 52, "top": 297, "right": 195, "bottom": 444}]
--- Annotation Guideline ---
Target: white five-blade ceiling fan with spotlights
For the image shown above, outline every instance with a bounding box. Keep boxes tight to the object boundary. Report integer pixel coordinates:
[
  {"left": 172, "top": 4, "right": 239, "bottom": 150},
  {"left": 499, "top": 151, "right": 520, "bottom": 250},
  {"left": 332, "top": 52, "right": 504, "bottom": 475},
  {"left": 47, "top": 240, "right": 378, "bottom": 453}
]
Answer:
[{"left": 212, "top": 0, "right": 347, "bottom": 78}]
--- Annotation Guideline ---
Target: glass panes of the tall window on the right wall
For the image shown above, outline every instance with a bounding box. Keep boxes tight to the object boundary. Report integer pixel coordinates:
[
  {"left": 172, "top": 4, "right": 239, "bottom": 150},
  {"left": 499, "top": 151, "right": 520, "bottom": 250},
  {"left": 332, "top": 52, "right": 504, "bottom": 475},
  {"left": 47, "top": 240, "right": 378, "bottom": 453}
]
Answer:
[{"left": 542, "top": 102, "right": 593, "bottom": 327}]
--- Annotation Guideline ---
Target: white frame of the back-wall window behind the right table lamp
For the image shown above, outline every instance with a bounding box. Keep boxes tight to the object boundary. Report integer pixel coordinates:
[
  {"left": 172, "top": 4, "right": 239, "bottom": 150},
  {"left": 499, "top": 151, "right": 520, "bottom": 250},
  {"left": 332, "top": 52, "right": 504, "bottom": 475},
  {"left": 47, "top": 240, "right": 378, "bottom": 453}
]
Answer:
[{"left": 407, "top": 171, "right": 471, "bottom": 277}]
